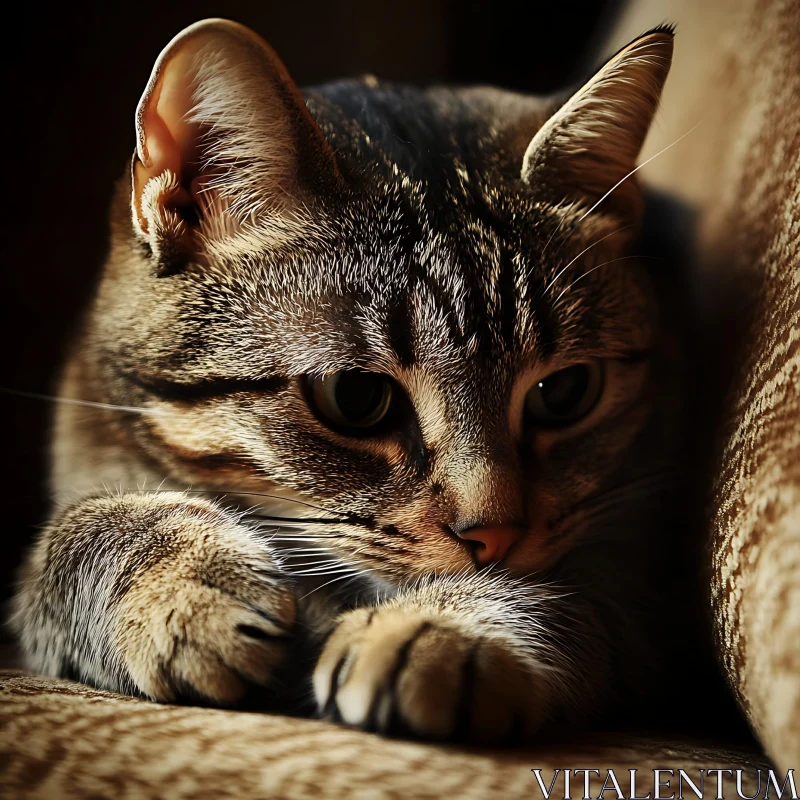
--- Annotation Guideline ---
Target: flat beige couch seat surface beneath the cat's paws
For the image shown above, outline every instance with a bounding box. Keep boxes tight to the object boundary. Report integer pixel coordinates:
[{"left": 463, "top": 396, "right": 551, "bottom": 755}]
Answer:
[{"left": 0, "top": 672, "right": 766, "bottom": 800}]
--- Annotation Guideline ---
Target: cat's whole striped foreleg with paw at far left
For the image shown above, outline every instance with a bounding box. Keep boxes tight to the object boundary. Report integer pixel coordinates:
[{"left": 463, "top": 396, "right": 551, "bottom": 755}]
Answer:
[{"left": 14, "top": 492, "right": 295, "bottom": 704}]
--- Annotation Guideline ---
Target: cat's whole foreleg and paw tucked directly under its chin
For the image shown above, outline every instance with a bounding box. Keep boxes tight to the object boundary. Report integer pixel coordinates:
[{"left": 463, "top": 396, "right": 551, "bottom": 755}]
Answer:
[{"left": 314, "top": 574, "right": 608, "bottom": 742}]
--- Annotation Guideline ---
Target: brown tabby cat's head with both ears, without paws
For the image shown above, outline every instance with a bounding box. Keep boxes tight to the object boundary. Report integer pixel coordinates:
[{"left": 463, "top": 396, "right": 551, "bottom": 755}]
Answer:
[{"left": 94, "top": 21, "right": 672, "bottom": 580}]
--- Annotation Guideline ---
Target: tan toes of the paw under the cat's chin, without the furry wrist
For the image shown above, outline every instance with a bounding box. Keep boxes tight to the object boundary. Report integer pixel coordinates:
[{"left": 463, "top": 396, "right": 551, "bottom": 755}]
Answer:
[{"left": 314, "top": 607, "right": 545, "bottom": 742}]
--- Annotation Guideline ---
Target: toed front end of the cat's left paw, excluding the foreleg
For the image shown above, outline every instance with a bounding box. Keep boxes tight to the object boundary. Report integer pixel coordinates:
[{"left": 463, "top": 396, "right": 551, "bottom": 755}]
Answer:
[{"left": 114, "top": 502, "right": 295, "bottom": 705}]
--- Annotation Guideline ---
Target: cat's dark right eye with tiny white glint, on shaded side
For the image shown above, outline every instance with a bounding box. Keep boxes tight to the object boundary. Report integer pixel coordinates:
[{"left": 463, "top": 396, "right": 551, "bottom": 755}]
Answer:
[{"left": 525, "top": 361, "right": 603, "bottom": 427}]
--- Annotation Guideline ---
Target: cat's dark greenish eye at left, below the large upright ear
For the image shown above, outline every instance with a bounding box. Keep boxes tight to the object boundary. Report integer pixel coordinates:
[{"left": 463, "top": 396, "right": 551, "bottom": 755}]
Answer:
[{"left": 309, "top": 370, "right": 392, "bottom": 431}]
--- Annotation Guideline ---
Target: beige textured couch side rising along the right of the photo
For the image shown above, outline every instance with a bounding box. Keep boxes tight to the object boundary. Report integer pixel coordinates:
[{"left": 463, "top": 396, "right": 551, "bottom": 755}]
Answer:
[{"left": 614, "top": 0, "right": 800, "bottom": 768}]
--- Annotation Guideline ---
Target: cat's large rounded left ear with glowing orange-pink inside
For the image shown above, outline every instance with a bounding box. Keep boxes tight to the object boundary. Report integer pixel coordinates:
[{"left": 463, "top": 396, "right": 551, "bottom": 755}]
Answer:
[{"left": 131, "top": 19, "right": 341, "bottom": 274}]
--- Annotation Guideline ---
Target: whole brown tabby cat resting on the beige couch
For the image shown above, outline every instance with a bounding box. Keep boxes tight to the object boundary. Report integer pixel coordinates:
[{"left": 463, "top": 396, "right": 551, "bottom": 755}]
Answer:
[{"left": 13, "top": 20, "right": 704, "bottom": 742}]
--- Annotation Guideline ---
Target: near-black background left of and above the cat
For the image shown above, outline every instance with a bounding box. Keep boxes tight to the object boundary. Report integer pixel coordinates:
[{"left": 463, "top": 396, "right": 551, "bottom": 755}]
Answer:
[{"left": 0, "top": 0, "right": 621, "bottom": 612}]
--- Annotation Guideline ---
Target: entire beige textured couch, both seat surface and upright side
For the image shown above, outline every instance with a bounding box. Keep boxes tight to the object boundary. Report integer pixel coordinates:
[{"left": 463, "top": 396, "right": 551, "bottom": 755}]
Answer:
[{"left": 0, "top": 0, "right": 800, "bottom": 798}]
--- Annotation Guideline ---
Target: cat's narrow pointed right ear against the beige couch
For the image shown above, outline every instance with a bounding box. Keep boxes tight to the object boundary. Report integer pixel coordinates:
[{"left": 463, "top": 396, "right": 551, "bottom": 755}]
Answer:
[{"left": 521, "top": 27, "right": 674, "bottom": 217}]
